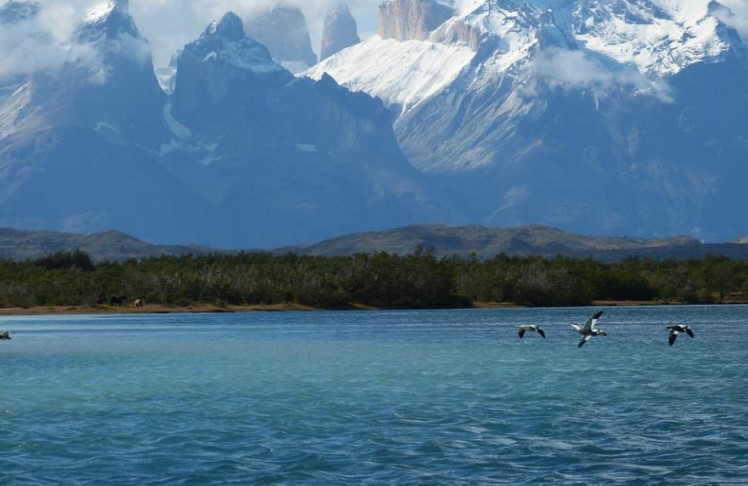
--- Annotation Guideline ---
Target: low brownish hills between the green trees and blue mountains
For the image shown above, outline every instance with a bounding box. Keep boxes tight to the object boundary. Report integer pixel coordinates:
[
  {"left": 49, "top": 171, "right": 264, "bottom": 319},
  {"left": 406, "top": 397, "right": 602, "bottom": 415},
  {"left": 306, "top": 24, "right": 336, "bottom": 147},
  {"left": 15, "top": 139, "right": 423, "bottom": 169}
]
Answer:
[{"left": 0, "top": 224, "right": 748, "bottom": 262}]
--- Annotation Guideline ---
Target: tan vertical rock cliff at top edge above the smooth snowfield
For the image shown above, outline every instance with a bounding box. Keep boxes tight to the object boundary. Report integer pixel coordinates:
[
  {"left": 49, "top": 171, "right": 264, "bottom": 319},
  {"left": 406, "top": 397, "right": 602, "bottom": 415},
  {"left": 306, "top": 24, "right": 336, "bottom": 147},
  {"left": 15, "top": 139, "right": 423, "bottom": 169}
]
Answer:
[{"left": 378, "top": 0, "right": 455, "bottom": 41}]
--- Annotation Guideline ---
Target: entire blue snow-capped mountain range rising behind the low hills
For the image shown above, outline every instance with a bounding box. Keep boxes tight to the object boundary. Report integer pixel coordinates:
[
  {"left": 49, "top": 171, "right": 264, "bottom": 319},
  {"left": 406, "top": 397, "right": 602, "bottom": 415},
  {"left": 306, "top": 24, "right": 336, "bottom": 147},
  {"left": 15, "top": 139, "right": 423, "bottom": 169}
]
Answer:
[{"left": 0, "top": 0, "right": 748, "bottom": 248}]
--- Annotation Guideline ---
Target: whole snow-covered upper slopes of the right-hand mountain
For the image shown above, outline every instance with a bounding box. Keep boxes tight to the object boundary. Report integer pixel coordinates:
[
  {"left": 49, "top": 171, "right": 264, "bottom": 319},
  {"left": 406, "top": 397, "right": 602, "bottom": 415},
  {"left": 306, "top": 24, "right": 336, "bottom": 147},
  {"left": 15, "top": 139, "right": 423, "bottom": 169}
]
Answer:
[{"left": 305, "top": 0, "right": 745, "bottom": 115}]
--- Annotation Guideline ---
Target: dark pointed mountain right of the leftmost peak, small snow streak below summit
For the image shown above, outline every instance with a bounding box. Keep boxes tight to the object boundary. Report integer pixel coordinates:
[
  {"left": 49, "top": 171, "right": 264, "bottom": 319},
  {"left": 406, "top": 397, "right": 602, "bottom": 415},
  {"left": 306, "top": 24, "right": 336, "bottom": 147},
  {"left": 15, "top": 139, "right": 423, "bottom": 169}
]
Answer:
[{"left": 163, "top": 14, "right": 458, "bottom": 246}]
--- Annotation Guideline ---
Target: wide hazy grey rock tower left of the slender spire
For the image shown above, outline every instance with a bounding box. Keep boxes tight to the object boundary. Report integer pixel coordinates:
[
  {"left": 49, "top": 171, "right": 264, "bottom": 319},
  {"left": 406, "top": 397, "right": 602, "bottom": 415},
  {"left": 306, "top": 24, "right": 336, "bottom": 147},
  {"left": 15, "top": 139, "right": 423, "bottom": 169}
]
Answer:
[{"left": 244, "top": 5, "right": 317, "bottom": 72}]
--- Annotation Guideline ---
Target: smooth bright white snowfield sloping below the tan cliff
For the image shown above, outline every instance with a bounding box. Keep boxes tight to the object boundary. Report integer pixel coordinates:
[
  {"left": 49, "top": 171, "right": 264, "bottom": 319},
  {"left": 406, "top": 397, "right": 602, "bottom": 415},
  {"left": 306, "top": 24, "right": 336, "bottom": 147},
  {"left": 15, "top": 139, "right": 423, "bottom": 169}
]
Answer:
[{"left": 303, "top": 35, "right": 475, "bottom": 113}]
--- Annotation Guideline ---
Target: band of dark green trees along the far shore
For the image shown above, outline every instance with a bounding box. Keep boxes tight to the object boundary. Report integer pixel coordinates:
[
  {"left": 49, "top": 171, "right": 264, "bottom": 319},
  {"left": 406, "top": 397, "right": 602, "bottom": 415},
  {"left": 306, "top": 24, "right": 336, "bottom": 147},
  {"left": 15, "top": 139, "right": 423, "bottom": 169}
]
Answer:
[{"left": 0, "top": 247, "right": 748, "bottom": 309}]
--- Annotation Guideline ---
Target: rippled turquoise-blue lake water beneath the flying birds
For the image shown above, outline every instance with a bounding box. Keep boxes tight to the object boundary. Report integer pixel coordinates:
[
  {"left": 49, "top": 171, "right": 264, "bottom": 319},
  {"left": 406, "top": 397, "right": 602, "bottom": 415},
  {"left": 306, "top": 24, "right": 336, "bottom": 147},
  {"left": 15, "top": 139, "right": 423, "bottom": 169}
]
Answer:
[{"left": 0, "top": 306, "right": 748, "bottom": 485}]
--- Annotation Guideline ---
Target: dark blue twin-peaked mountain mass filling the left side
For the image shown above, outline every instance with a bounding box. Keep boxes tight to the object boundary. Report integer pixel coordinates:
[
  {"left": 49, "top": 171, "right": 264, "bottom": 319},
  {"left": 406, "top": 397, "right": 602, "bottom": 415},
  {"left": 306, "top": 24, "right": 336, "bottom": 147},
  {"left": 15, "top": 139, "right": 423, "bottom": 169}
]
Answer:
[{"left": 0, "top": 0, "right": 459, "bottom": 248}]
